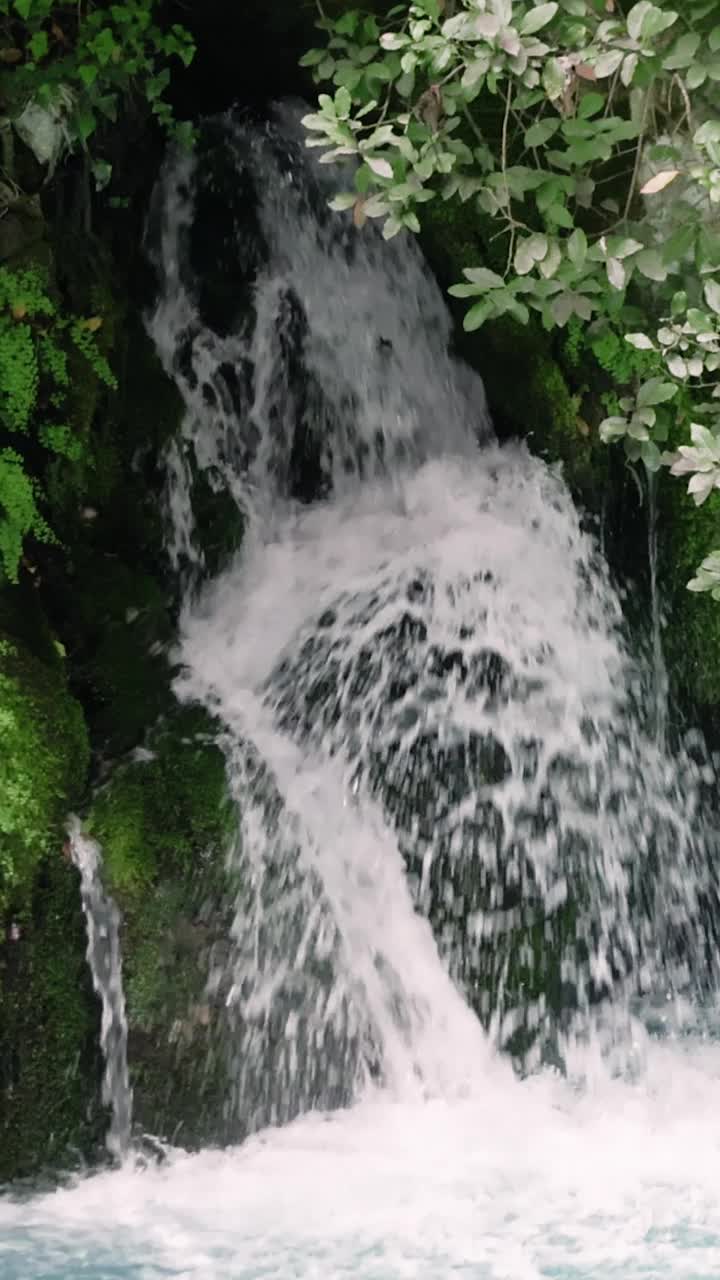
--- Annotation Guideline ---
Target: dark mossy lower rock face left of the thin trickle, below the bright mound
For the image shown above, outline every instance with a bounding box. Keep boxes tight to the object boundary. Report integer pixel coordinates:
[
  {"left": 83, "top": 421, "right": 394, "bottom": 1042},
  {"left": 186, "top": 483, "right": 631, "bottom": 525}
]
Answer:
[{"left": 0, "top": 847, "right": 108, "bottom": 1183}]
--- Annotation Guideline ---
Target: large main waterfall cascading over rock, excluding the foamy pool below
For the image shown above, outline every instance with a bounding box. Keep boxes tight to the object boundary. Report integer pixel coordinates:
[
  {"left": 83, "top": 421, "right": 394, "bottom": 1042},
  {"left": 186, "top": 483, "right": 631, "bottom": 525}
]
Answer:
[{"left": 141, "top": 108, "right": 717, "bottom": 1129}]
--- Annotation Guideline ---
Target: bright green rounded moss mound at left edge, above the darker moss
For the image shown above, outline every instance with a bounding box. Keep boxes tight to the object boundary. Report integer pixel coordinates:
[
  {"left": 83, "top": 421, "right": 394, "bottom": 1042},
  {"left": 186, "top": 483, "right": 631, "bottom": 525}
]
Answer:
[{"left": 0, "top": 632, "right": 90, "bottom": 911}]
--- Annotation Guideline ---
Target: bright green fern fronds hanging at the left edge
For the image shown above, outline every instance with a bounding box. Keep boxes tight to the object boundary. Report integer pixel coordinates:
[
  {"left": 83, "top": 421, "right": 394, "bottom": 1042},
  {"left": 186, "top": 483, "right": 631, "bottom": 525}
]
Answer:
[{"left": 0, "top": 268, "right": 117, "bottom": 581}]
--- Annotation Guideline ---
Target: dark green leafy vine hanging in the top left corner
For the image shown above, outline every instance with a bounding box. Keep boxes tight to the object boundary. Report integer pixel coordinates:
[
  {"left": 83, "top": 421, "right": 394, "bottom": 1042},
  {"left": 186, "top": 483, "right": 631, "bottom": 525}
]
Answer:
[{"left": 0, "top": 0, "right": 195, "bottom": 187}]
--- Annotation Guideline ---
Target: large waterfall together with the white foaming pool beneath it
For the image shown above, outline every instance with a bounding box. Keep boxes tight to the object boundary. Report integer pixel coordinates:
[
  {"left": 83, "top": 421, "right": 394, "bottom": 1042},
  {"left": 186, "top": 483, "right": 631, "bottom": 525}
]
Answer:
[{"left": 0, "top": 113, "right": 720, "bottom": 1280}]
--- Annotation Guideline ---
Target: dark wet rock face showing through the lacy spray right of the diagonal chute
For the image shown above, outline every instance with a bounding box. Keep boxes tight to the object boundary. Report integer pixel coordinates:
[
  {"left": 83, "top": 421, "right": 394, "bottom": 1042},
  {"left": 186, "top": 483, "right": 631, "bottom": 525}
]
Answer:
[{"left": 258, "top": 555, "right": 715, "bottom": 1066}]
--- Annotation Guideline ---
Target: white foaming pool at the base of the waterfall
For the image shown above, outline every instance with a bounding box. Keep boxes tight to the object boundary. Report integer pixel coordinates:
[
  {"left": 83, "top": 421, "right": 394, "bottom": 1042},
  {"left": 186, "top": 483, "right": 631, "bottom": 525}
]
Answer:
[{"left": 0, "top": 1042, "right": 720, "bottom": 1280}]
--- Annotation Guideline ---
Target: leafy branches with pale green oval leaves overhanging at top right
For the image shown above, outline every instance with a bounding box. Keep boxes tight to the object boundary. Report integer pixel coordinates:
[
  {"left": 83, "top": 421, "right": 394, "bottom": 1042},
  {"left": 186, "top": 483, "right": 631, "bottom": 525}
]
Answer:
[{"left": 302, "top": 0, "right": 720, "bottom": 589}]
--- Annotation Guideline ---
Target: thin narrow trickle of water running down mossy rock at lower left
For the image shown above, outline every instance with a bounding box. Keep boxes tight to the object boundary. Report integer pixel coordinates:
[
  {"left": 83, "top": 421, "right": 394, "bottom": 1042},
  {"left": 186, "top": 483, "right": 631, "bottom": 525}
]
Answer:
[{"left": 68, "top": 818, "right": 132, "bottom": 1160}]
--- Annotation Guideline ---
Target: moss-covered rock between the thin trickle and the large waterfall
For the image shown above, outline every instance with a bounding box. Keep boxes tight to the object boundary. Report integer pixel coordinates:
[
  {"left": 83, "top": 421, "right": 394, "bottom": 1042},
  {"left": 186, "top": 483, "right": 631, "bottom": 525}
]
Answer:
[{"left": 87, "top": 708, "right": 236, "bottom": 1144}]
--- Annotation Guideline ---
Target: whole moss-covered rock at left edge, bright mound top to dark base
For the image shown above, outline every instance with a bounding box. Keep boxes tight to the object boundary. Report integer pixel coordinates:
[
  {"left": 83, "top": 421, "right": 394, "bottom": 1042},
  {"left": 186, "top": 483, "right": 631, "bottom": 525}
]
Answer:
[{"left": 0, "top": 584, "right": 105, "bottom": 1181}]
